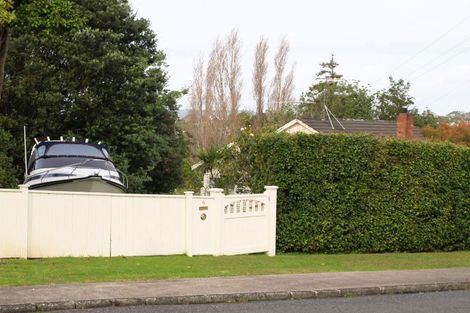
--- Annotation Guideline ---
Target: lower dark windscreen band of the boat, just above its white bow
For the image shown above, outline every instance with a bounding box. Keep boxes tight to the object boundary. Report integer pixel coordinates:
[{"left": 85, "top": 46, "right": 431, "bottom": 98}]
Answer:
[{"left": 31, "top": 157, "right": 116, "bottom": 171}]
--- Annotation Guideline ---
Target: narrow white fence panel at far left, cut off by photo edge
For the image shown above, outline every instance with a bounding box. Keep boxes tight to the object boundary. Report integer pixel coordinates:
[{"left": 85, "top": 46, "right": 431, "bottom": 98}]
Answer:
[{"left": 0, "top": 189, "right": 28, "bottom": 258}]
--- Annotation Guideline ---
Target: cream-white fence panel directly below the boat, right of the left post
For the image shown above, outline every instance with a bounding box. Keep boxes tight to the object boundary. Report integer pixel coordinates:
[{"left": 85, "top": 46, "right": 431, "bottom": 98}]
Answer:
[{"left": 28, "top": 191, "right": 111, "bottom": 258}]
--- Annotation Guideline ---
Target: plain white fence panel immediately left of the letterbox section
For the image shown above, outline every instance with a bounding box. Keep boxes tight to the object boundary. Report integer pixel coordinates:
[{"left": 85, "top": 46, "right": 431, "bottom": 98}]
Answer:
[{"left": 111, "top": 195, "right": 186, "bottom": 256}]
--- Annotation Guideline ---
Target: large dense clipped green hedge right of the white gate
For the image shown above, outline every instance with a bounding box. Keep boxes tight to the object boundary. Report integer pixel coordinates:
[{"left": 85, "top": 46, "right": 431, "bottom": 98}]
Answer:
[{"left": 238, "top": 134, "right": 470, "bottom": 253}]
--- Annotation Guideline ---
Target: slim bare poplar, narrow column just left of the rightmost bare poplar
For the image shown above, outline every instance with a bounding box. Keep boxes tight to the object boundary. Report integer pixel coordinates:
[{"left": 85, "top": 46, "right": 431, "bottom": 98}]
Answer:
[{"left": 252, "top": 37, "right": 268, "bottom": 127}]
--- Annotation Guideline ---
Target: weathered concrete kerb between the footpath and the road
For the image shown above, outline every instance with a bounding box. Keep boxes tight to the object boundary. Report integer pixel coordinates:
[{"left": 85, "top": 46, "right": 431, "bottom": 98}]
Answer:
[{"left": 0, "top": 282, "right": 470, "bottom": 313}]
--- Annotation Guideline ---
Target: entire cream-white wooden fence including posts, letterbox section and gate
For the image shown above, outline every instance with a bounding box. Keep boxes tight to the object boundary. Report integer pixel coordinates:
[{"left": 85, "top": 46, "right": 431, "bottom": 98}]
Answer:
[{"left": 0, "top": 185, "right": 277, "bottom": 258}]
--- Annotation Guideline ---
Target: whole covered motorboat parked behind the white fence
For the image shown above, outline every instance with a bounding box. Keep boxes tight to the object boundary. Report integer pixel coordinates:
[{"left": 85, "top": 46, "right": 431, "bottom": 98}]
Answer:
[{"left": 24, "top": 140, "right": 128, "bottom": 193}]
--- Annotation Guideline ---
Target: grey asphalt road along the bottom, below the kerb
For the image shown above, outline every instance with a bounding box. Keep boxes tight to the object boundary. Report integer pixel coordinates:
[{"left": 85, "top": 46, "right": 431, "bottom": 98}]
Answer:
[{"left": 55, "top": 291, "right": 470, "bottom": 313}]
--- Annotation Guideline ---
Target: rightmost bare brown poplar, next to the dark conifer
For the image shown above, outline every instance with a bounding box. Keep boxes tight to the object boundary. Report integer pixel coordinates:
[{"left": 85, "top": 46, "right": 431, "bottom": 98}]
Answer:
[{"left": 268, "top": 38, "right": 294, "bottom": 111}]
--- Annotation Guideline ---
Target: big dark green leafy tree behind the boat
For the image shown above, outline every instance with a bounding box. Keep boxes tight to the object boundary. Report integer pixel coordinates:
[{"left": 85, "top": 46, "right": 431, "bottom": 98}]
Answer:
[{"left": 0, "top": 0, "right": 185, "bottom": 192}]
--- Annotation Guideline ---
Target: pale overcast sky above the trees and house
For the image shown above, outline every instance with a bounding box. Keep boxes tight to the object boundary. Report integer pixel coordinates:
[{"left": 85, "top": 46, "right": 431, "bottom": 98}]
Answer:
[{"left": 130, "top": 0, "right": 470, "bottom": 115}]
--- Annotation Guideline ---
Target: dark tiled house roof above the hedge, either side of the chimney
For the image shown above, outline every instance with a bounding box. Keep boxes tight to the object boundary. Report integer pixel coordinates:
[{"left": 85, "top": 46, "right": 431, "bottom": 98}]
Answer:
[{"left": 296, "top": 119, "right": 423, "bottom": 138}]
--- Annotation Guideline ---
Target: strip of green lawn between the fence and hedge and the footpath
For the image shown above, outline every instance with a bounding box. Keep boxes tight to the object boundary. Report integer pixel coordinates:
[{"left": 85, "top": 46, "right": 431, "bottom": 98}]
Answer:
[{"left": 0, "top": 251, "right": 470, "bottom": 286}]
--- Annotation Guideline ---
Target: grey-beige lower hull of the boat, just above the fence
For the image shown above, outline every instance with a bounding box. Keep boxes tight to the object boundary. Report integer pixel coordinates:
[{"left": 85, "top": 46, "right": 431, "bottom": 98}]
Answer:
[{"left": 29, "top": 176, "right": 126, "bottom": 193}]
